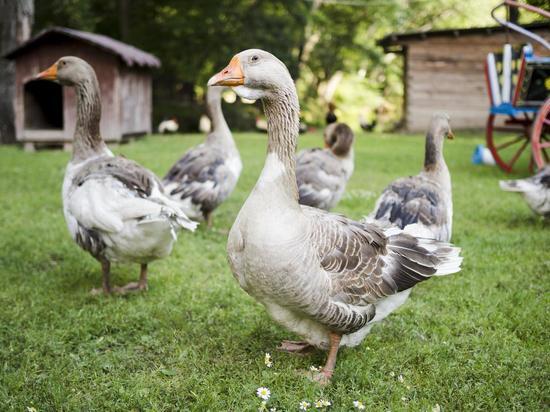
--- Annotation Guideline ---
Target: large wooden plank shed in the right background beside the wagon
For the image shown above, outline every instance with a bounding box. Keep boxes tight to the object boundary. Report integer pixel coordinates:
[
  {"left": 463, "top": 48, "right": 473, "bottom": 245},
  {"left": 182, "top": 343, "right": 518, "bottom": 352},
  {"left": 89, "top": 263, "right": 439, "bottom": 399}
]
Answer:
[{"left": 378, "top": 22, "right": 550, "bottom": 132}]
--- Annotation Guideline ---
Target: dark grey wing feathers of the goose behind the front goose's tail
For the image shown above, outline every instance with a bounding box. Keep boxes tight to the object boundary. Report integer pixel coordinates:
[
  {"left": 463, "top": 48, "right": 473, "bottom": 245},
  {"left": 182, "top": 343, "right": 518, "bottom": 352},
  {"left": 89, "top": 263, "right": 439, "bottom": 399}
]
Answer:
[{"left": 371, "top": 176, "right": 446, "bottom": 229}]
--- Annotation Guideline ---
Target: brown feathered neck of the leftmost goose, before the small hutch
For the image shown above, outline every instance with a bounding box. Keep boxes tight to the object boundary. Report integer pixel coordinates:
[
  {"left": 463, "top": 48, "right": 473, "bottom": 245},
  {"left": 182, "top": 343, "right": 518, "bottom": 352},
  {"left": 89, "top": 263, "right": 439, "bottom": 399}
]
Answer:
[{"left": 73, "top": 75, "right": 106, "bottom": 160}]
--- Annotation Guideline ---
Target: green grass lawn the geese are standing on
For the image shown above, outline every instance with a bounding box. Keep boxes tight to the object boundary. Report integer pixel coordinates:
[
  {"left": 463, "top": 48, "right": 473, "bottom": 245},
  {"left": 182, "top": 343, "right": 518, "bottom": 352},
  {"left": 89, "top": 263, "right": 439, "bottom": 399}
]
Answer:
[{"left": 0, "top": 133, "right": 550, "bottom": 411}]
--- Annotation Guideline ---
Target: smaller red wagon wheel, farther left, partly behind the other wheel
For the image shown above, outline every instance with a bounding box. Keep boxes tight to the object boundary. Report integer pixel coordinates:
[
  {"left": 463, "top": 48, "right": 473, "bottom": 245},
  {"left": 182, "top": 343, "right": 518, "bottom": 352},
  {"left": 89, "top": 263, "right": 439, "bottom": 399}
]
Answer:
[{"left": 486, "top": 113, "right": 533, "bottom": 173}]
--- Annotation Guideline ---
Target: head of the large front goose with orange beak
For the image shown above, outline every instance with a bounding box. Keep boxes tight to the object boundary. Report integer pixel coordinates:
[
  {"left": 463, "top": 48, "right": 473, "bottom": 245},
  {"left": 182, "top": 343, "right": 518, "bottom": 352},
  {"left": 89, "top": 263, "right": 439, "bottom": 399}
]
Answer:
[{"left": 208, "top": 49, "right": 294, "bottom": 100}]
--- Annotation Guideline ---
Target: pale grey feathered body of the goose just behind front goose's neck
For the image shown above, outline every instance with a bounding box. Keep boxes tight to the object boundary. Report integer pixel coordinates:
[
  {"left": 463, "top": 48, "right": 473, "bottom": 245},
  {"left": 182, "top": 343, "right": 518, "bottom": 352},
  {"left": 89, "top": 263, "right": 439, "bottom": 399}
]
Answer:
[{"left": 296, "top": 149, "right": 346, "bottom": 209}]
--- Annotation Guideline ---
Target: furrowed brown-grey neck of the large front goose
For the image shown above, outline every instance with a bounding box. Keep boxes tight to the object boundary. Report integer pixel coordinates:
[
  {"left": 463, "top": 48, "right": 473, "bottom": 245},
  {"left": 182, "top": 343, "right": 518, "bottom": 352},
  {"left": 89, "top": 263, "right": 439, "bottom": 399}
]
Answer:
[{"left": 263, "top": 84, "right": 300, "bottom": 204}]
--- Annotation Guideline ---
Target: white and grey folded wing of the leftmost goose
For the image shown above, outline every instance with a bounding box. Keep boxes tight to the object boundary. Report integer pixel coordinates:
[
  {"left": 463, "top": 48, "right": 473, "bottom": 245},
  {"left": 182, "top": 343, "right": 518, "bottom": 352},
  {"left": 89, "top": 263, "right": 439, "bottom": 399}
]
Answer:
[{"left": 68, "top": 156, "right": 196, "bottom": 232}]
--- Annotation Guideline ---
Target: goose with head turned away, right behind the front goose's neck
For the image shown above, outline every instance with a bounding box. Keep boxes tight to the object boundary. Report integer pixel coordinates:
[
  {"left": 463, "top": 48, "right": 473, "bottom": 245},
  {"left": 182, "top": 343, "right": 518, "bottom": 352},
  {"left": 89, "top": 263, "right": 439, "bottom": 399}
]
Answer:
[{"left": 296, "top": 123, "right": 353, "bottom": 210}]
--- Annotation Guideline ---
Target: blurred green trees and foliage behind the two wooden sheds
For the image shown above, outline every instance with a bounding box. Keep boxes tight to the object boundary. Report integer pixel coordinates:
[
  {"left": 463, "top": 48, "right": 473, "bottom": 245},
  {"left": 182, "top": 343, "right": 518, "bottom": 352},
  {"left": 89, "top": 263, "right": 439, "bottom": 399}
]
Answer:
[{"left": 35, "top": 0, "right": 512, "bottom": 130}]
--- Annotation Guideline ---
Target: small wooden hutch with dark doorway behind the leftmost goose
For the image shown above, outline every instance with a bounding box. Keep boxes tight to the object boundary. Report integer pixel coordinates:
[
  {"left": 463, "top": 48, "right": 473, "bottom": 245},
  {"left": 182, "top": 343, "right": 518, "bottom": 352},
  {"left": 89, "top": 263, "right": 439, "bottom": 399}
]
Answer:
[{"left": 5, "top": 27, "right": 160, "bottom": 149}]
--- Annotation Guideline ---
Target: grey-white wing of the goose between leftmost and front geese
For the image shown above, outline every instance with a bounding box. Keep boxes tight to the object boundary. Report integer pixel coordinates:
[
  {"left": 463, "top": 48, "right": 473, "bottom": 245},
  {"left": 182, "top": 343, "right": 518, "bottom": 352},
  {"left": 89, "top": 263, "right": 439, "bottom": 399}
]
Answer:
[{"left": 163, "top": 145, "right": 235, "bottom": 210}]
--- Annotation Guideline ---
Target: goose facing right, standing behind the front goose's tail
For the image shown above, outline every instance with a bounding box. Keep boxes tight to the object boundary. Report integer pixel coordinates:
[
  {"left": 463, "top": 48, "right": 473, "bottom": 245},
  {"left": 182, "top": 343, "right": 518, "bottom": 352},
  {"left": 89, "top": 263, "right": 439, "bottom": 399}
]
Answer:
[{"left": 368, "top": 113, "right": 454, "bottom": 242}]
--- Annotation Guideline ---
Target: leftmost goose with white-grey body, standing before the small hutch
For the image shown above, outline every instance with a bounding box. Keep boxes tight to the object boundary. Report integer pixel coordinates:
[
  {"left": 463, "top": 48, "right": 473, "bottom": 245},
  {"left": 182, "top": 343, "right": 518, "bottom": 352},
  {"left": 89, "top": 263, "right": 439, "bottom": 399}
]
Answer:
[{"left": 36, "top": 56, "right": 196, "bottom": 294}]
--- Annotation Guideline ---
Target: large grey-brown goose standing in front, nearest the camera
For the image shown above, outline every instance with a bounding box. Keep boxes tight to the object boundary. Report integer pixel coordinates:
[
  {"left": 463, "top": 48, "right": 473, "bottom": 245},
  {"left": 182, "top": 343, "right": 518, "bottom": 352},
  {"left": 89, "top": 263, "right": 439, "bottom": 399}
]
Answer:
[{"left": 208, "top": 49, "right": 461, "bottom": 384}]
